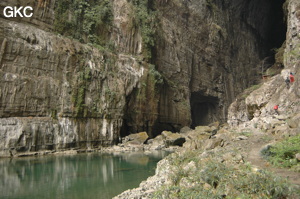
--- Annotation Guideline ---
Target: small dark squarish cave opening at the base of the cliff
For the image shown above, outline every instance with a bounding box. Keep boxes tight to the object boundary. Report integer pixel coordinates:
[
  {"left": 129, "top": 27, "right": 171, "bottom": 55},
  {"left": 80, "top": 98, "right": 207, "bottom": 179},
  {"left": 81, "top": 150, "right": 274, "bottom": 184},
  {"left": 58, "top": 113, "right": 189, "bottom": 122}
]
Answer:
[{"left": 190, "top": 92, "right": 218, "bottom": 128}]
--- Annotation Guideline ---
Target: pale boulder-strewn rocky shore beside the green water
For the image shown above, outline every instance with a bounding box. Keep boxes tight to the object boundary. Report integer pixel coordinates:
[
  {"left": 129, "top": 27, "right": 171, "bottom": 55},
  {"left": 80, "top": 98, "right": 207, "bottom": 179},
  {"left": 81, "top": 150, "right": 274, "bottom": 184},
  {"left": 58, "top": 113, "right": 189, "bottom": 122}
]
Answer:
[{"left": 114, "top": 109, "right": 300, "bottom": 199}]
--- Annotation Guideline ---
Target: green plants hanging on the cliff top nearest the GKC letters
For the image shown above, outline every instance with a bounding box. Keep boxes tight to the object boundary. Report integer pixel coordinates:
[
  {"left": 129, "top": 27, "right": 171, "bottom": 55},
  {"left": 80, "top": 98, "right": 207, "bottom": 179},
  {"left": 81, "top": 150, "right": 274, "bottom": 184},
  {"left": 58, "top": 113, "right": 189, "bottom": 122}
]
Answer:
[{"left": 54, "top": 0, "right": 113, "bottom": 45}]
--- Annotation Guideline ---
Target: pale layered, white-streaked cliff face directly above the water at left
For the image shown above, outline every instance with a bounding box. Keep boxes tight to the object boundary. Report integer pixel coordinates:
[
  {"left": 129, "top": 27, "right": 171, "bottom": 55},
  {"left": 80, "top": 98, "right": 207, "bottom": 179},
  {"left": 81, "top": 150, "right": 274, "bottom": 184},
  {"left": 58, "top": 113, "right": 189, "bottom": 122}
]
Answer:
[{"left": 0, "top": 1, "right": 147, "bottom": 156}]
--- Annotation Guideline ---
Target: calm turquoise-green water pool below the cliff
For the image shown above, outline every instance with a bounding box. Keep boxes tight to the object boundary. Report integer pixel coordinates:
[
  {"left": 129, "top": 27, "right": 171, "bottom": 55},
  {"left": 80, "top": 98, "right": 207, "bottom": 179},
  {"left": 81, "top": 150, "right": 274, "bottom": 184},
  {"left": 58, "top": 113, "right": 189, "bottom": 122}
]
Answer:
[{"left": 0, "top": 152, "right": 167, "bottom": 199}]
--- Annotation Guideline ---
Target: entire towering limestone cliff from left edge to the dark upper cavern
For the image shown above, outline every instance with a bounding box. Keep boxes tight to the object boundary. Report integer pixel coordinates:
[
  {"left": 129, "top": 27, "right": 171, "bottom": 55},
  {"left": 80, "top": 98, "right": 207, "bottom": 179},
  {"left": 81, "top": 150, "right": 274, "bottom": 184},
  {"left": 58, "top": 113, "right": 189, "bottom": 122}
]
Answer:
[{"left": 0, "top": 0, "right": 290, "bottom": 155}]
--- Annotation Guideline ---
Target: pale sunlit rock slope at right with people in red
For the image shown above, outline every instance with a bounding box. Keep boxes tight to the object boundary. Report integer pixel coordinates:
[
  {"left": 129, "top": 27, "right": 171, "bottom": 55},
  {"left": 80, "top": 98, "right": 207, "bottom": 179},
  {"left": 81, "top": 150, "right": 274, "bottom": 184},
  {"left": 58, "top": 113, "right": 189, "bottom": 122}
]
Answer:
[{"left": 228, "top": 1, "right": 300, "bottom": 127}]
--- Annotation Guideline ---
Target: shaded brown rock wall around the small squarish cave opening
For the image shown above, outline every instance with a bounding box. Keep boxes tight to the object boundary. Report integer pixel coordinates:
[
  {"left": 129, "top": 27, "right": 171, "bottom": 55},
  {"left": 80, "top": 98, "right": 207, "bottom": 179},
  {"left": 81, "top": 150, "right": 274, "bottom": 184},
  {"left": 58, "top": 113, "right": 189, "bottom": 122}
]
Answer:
[{"left": 151, "top": 0, "right": 284, "bottom": 130}]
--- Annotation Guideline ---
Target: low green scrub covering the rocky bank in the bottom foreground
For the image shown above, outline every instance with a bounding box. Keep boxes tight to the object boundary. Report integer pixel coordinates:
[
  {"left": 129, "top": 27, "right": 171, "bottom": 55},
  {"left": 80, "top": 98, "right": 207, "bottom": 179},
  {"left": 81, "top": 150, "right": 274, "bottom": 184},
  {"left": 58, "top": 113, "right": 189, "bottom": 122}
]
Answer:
[{"left": 153, "top": 152, "right": 296, "bottom": 199}]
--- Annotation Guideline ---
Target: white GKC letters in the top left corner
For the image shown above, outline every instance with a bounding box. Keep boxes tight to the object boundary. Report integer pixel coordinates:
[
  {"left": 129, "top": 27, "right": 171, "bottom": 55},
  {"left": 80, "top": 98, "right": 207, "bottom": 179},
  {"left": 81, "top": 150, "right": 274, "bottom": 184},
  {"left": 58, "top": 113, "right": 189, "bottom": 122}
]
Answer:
[{"left": 3, "top": 6, "right": 33, "bottom": 18}]
